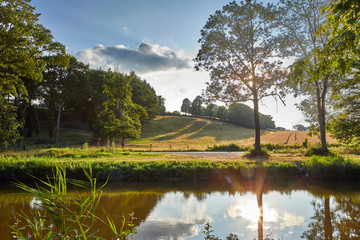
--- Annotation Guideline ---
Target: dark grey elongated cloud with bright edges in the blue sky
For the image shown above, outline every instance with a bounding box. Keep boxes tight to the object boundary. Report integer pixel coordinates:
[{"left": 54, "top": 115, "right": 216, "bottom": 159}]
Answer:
[{"left": 77, "top": 42, "right": 193, "bottom": 73}]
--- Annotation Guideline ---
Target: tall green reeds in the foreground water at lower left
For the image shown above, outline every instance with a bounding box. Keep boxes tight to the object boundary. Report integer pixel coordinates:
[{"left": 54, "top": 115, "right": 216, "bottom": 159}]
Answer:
[{"left": 11, "top": 167, "right": 137, "bottom": 240}]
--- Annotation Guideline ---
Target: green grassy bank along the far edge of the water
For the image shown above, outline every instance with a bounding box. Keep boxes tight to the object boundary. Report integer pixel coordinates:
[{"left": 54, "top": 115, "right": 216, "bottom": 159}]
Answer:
[{"left": 0, "top": 149, "right": 360, "bottom": 182}]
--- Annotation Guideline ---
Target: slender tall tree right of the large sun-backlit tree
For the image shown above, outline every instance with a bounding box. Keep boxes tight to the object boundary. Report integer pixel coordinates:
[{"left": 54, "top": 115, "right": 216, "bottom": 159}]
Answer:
[{"left": 279, "top": 0, "right": 341, "bottom": 151}]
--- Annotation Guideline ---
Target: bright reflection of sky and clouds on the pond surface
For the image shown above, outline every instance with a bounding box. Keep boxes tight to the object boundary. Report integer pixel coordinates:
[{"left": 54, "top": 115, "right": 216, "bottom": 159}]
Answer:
[{"left": 136, "top": 191, "right": 313, "bottom": 239}]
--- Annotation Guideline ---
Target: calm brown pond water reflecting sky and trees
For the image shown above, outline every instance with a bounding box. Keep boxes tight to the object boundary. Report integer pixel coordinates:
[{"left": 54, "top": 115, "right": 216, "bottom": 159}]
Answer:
[{"left": 0, "top": 179, "right": 360, "bottom": 240}]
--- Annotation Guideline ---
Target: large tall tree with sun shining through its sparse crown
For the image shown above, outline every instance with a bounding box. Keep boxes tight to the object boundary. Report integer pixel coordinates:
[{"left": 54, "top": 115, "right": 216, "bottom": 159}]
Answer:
[{"left": 195, "top": 0, "right": 285, "bottom": 153}]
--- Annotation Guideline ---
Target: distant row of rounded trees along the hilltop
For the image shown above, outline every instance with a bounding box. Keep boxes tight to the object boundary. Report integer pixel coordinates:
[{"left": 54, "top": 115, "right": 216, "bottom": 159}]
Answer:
[{"left": 181, "top": 96, "right": 275, "bottom": 129}]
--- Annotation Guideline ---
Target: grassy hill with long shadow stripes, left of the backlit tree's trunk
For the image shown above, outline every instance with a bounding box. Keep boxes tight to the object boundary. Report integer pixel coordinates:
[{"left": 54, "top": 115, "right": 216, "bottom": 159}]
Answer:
[{"left": 129, "top": 116, "right": 262, "bottom": 150}]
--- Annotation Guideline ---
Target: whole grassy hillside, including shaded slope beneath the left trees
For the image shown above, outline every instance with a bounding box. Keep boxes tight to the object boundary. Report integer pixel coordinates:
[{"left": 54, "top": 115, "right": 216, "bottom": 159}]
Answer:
[{"left": 19, "top": 116, "right": 335, "bottom": 151}]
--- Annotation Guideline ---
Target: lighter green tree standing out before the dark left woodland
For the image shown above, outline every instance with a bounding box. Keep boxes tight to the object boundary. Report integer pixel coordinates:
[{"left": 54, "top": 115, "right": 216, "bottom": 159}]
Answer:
[{"left": 99, "top": 72, "right": 146, "bottom": 147}]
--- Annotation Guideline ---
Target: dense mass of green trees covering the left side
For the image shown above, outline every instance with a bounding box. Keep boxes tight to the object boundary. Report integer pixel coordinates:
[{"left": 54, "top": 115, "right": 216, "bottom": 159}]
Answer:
[{"left": 0, "top": 0, "right": 165, "bottom": 149}]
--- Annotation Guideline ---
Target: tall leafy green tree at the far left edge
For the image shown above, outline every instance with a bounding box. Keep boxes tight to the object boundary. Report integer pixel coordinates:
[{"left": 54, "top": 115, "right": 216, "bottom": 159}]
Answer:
[{"left": 0, "top": 0, "right": 65, "bottom": 146}]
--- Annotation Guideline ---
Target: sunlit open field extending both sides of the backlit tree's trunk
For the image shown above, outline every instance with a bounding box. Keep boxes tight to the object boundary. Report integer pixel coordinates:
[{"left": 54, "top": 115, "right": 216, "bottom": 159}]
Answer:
[{"left": 129, "top": 116, "right": 336, "bottom": 151}]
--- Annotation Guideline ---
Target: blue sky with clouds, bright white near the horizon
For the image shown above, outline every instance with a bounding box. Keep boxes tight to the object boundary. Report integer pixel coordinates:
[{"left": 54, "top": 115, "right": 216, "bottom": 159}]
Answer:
[{"left": 31, "top": 0, "right": 304, "bottom": 129}]
